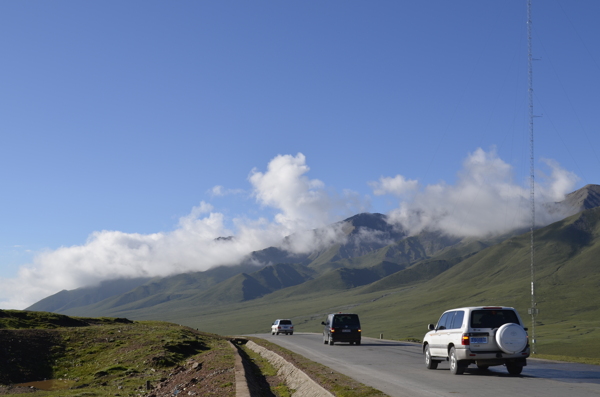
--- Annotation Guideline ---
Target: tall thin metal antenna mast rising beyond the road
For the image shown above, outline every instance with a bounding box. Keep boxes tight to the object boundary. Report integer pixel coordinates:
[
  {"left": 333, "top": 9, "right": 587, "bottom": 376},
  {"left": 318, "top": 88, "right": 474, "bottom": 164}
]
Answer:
[{"left": 527, "top": 0, "right": 538, "bottom": 354}]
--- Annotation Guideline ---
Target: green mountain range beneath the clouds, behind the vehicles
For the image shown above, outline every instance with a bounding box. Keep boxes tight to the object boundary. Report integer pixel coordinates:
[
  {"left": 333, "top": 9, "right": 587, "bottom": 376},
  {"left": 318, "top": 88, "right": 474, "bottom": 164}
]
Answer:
[{"left": 27, "top": 185, "right": 600, "bottom": 356}]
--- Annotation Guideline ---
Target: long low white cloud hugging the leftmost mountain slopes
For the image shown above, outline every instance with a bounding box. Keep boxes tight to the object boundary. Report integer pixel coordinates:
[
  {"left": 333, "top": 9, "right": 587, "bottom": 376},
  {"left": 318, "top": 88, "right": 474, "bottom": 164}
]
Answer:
[{"left": 0, "top": 203, "right": 262, "bottom": 308}]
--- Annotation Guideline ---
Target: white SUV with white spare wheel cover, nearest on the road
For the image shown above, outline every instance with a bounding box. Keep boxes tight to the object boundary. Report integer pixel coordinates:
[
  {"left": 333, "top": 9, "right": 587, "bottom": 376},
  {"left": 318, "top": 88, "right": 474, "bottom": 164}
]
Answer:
[{"left": 423, "top": 307, "right": 529, "bottom": 375}]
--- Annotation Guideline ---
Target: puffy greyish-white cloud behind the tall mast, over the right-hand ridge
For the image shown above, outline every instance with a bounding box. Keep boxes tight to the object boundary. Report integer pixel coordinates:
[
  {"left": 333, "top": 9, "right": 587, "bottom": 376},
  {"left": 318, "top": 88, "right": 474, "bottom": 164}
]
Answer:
[{"left": 390, "top": 149, "right": 577, "bottom": 236}]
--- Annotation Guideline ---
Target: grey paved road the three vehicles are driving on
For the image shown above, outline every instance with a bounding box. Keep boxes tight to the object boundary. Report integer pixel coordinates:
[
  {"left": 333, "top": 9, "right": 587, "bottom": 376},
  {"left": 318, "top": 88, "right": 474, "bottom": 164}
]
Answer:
[{"left": 251, "top": 333, "right": 600, "bottom": 397}]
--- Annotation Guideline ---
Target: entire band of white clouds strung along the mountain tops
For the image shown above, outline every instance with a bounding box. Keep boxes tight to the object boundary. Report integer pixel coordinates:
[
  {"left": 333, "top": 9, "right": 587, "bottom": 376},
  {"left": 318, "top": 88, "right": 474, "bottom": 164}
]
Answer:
[{"left": 0, "top": 149, "right": 577, "bottom": 309}]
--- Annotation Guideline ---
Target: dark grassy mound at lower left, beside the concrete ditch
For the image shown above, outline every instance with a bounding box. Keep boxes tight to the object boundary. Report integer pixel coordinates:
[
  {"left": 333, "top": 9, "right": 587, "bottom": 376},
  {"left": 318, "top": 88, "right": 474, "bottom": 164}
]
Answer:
[{"left": 0, "top": 310, "right": 235, "bottom": 396}]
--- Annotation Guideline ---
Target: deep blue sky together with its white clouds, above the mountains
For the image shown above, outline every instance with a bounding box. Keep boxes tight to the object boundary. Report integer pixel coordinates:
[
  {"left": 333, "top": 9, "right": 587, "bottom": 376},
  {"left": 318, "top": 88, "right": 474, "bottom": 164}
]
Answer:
[{"left": 0, "top": 0, "right": 600, "bottom": 308}]
